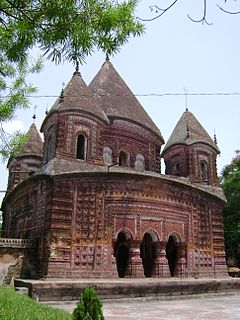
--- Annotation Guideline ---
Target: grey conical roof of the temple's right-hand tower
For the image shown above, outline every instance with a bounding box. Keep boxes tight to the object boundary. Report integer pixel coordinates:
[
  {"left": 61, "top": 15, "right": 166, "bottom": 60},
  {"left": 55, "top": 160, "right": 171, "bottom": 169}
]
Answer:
[{"left": 163, "top": 110, "right": 220, "bottom": 153}]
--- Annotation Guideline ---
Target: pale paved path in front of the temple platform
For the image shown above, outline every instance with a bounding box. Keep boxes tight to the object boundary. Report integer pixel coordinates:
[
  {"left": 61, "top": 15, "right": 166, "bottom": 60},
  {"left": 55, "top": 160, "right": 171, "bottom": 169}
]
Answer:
[{"left": 47, "top": 292, "right": 240, "bottom": 320}]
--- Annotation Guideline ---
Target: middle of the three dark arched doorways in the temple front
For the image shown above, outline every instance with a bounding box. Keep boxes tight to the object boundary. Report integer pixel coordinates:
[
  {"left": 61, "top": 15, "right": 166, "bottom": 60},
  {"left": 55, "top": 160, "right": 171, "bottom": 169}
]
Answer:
[{"left": 140, "top": 232, "right": 156, "bottom": 277}]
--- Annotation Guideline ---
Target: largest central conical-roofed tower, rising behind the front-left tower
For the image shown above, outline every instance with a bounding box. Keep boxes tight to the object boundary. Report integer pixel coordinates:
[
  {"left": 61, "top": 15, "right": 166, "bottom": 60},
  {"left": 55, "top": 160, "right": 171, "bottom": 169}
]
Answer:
[{"left": 89, "top": 61, "right": 164, "bottom": 172}]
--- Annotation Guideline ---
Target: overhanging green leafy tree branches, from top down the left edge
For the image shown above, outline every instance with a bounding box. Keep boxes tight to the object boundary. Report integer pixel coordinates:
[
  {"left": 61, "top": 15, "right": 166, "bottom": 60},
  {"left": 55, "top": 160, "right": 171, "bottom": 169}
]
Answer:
[{"left": 0, "top": 0, "right": 144, "bottom": 160}]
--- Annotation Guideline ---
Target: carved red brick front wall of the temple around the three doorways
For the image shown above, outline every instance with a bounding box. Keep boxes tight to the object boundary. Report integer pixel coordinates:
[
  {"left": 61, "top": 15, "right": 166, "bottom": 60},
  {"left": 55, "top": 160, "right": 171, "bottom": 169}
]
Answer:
[{"left": 27, "top": 174, "right": 226, "bottom": 277}]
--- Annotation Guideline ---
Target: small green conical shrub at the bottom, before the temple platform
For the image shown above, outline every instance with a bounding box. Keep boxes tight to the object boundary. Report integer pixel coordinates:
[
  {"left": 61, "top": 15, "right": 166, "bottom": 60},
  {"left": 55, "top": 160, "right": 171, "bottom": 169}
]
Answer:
[{"left": 72, "top": 287, "right": 104, "bottom": 320}]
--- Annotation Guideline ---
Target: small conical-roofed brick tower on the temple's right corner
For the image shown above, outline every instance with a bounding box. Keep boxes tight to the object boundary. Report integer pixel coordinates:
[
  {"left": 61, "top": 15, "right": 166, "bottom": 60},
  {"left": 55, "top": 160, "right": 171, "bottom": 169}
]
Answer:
[{"left": 162, "top": 109, "right": 220, "bottom": 185}]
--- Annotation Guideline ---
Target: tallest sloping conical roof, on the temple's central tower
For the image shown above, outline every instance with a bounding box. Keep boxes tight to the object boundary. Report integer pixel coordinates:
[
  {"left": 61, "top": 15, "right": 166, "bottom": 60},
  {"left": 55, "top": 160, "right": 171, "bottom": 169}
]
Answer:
[{"left": 89, "top": 61, "right": 163, "bottom": 140}]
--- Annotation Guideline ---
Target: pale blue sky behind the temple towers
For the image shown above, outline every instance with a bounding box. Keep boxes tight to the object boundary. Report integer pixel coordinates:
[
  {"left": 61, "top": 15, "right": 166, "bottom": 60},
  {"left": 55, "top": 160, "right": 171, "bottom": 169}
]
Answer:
[{"left": 0, "top": 0, "right": 240, "bottom": 206}]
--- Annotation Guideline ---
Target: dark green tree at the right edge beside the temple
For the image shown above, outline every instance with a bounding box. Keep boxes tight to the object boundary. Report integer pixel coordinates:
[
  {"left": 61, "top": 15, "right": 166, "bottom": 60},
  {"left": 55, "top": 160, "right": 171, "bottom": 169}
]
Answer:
[{"left": 221, "top": 151, "right": 240, "bottom": 265}]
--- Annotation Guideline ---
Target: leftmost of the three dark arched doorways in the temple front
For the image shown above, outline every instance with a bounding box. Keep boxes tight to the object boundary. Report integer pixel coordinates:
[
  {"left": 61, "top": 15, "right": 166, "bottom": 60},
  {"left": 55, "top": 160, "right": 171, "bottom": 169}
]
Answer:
[{"left": 115, "top": 232, "right": 129, "bottom": 278}]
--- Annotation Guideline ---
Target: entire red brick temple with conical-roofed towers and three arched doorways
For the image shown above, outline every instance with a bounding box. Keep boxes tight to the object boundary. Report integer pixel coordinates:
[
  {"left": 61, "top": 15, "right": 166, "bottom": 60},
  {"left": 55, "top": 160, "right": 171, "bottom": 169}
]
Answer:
[{"left": 2, "top": 61, "right": 226, "bottom": 279}]
